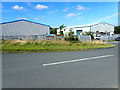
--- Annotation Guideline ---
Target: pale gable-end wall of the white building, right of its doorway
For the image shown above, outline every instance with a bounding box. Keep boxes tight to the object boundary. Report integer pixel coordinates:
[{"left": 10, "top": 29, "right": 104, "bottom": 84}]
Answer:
[{"left": 91, "top": 23, "right": 114, "bottom": 34}]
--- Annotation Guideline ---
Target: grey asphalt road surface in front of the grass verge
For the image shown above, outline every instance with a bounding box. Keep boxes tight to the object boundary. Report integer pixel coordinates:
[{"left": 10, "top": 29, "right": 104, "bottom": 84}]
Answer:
[{"left": 2, "top": 42, "right": 118, "bottom": 88}]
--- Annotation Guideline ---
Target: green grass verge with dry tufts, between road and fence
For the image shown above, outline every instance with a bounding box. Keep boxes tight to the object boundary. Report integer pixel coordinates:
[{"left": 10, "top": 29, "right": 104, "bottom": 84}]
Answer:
[{"left": 1, "top": 40, "right": 115, "bottom": 53}]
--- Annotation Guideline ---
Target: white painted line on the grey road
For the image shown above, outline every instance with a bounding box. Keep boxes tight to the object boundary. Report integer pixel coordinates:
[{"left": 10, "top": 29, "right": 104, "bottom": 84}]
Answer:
[{"left": 43, "top": 55, "right": 114, "bottom": 66}]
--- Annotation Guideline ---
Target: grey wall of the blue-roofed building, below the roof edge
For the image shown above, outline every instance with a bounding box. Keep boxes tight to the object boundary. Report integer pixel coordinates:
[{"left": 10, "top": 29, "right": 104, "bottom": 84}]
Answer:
[{"left": 0, "top": 21, "right": 50, "bottom": 36}]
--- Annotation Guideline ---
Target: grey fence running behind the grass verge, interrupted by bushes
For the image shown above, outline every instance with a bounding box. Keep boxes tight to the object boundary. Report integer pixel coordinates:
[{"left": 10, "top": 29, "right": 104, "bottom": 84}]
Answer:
[{"left": 1, "top": 34, "right": 120, "bottom": 42}]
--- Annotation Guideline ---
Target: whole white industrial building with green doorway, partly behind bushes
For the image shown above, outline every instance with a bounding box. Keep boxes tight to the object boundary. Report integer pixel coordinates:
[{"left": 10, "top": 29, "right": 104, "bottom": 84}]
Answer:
[{"left": 57, "top": 22, "right": 114, "bottom": 36}]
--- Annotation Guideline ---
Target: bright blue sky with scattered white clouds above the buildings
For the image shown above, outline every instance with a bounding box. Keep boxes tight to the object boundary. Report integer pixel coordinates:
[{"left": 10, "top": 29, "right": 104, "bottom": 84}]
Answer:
[{"left": 0, "top": 2, "right": 119, "bottom": 27}]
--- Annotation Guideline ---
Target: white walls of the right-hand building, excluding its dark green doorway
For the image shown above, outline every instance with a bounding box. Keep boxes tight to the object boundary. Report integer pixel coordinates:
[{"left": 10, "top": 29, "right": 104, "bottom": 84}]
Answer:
[{"left": 58, "top": 23, "right": 114, "bottom": 35}]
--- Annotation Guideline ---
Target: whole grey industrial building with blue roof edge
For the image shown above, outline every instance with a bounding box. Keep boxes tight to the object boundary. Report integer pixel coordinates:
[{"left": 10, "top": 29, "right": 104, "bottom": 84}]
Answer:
[{"left": 0, "top": 19, "right": 50, "bottom": 40}]
